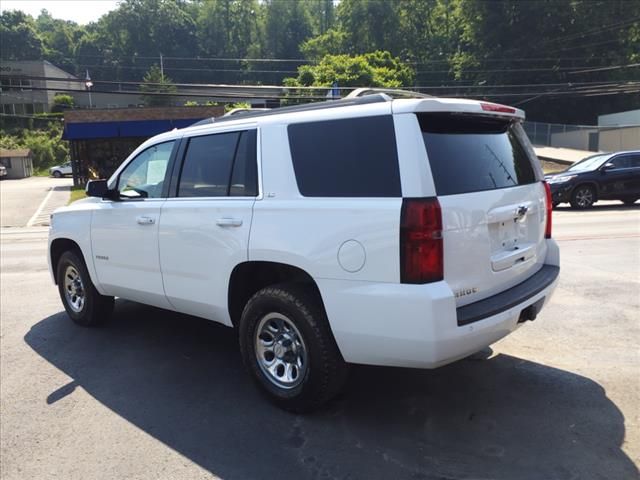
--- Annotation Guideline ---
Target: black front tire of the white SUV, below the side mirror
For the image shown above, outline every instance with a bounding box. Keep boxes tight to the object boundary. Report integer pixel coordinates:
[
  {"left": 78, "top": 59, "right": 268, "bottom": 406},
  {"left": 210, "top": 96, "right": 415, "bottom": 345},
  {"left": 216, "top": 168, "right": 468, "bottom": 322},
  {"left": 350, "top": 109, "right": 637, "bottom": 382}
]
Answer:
[{"left": 56, "top": 251, "right": 114, "bottom": 327}]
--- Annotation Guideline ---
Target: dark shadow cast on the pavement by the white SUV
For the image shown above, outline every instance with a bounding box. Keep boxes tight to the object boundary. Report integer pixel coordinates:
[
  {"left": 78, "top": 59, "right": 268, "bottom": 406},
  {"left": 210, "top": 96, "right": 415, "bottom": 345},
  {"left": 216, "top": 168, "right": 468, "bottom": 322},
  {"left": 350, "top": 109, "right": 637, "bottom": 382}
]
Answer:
[{"left": 25, "top": 301, "right": 638, "bottom": 480}]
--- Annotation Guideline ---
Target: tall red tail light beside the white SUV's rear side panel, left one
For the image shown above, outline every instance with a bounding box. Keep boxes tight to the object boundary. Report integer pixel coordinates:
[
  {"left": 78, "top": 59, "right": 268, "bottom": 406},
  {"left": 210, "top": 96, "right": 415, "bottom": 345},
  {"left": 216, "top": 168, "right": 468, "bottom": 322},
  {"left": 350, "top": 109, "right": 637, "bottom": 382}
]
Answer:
[{"left": 400, "top": 198, "right": 444, "bottom": 283}]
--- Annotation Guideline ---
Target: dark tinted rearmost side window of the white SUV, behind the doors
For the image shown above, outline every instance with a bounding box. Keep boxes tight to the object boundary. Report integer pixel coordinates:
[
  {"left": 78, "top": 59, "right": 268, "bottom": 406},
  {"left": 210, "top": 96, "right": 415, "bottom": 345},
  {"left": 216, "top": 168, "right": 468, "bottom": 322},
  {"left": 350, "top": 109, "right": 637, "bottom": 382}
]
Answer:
[{"left": 288, "top": 115, "right": 401, "bottom": 197}]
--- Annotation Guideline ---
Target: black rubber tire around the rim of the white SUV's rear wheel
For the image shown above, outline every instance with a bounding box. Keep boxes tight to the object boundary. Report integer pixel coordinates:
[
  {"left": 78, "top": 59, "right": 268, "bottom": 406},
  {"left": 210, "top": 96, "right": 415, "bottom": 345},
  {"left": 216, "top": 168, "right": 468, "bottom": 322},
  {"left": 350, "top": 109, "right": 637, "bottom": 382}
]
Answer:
[{"left": 239, "top": 284, "right": 348, "bottom": 413}]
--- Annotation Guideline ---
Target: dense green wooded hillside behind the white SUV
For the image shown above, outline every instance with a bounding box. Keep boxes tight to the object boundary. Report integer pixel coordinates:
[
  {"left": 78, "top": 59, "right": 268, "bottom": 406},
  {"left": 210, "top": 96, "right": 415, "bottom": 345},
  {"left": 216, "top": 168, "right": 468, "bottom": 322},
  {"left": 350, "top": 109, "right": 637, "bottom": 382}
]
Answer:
[{"left": 0, "top": 0, "right": 640, "bottom": 121}]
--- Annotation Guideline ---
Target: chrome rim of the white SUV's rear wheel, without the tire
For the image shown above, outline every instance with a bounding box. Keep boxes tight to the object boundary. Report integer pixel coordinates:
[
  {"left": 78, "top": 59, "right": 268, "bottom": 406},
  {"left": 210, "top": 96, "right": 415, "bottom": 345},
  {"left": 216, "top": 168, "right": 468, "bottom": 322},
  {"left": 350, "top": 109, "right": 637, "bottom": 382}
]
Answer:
[{"left": 255, "top": 312, "right": 308, "bottom": 389}]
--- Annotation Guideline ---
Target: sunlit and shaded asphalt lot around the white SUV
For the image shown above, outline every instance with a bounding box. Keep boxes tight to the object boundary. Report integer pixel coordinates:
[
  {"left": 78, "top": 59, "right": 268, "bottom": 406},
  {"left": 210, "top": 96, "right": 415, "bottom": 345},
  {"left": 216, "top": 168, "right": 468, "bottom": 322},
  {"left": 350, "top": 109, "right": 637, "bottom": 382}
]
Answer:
[{"left": 0, "top": 202, "right": 640, "bottom": 480}]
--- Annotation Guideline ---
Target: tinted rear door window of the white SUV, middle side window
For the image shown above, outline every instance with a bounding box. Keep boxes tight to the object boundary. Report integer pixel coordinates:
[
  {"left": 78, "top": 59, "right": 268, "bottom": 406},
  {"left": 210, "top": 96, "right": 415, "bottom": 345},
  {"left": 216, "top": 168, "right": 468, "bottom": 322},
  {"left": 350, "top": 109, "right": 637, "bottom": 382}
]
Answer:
[{"left": 178, "top": 130, "right": 258, "bottom": 197}]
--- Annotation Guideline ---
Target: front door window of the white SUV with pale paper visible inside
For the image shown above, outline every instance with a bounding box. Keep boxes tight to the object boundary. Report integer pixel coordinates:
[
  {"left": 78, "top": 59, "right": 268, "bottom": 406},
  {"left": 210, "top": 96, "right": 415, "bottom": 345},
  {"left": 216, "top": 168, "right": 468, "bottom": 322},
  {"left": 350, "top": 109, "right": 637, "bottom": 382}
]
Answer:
[{"left": 118, "top": 141, "right": 175, "bottom": 198}]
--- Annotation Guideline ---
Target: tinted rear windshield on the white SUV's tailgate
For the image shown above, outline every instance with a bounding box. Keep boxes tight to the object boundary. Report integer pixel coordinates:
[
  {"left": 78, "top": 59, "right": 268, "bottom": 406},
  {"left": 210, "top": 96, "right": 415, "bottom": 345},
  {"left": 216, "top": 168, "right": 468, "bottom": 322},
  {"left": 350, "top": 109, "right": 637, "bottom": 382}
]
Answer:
[{"left": 418, "top": 113, "right": 540, "bottom": 195}]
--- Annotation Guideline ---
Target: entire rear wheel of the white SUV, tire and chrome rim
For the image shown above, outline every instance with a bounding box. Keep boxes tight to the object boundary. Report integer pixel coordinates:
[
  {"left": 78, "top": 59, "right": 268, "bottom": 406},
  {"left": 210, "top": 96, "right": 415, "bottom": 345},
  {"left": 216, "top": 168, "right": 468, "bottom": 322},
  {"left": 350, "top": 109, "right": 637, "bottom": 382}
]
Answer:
[{"left": 239, "top": 284, "right": 347, "bottom": 413}]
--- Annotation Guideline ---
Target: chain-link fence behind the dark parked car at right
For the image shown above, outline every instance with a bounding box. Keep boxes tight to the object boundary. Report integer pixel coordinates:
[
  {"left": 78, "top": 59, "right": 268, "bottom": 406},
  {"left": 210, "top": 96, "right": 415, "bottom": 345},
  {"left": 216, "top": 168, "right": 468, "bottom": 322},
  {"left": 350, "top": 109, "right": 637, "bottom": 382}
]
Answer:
[{"left": 524, "top": 122, "right": 640, "bottom": 152}]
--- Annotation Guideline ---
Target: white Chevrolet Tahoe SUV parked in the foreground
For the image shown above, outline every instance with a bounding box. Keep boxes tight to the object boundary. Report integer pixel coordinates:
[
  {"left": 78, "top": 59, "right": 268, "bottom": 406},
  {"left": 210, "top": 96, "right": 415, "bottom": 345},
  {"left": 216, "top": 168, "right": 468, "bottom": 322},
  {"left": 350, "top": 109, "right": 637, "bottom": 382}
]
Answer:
[{"left": 49, "top": 94, "right": 559, "bottom": 411}]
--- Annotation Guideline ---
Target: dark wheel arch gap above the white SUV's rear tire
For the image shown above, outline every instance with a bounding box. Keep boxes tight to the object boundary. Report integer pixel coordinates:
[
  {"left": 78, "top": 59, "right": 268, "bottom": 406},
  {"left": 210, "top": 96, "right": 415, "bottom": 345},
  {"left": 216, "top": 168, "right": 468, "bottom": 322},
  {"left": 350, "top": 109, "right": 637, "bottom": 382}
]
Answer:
[{"left": 227, "top": 260, "right": 324, "bottom": 327}]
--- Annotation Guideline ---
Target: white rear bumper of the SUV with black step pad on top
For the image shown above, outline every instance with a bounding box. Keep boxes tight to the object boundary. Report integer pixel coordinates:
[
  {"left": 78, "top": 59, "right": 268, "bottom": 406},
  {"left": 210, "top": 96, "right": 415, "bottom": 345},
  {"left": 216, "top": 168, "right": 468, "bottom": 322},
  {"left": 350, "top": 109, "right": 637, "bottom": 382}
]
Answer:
[{"left": 318, "top": 240, "right": 559, "bottom": 368}]
